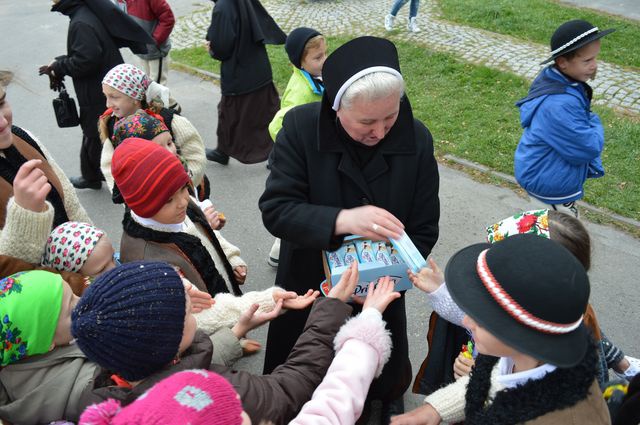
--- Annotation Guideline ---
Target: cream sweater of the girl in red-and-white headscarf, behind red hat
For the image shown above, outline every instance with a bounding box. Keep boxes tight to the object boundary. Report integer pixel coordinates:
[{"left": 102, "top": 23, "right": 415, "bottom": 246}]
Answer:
[{"left": 100, "top": 115, "right": 207, "bottom": 192}]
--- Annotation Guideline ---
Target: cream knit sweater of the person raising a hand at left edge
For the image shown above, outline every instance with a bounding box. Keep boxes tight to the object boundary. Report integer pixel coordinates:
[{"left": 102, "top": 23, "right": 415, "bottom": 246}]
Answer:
[{"left": 0, "top": 131, "right": 91, "bottom": 264}]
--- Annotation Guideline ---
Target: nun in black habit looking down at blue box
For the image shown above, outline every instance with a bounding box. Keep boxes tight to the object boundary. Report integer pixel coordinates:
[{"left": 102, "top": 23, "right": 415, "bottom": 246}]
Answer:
[{"left": 259, "top": 37, "right": 440, "bottom": 420}]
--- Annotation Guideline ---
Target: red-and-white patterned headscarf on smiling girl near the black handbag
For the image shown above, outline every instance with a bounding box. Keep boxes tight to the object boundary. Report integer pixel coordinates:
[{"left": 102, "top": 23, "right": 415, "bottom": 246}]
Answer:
[{"left": 102, "top": 63, "right": 169, "bottom": 106}]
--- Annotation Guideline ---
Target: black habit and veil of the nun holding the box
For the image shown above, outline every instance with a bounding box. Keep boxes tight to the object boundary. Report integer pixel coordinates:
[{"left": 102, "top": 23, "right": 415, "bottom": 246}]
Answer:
[{"left": 259, "top": 37, "right": 440, "bottom": 401}]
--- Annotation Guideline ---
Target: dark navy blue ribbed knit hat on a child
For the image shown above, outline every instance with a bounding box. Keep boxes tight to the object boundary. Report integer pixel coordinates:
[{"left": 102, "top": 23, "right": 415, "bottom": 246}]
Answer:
[{"left": 71, "top": 261, "right": 186, "bottom": 381}]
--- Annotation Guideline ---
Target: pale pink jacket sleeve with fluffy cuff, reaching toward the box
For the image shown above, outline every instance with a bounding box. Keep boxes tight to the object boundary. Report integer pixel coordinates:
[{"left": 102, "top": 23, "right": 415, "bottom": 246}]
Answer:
[{"left": 291, "top": 308, "right": 391, "bottom": 425}]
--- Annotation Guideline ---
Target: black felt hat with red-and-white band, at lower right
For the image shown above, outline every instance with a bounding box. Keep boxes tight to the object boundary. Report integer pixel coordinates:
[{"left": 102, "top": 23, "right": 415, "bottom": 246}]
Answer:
[{"left": 445, "top": 234, "right": 590, "bottom": 367}]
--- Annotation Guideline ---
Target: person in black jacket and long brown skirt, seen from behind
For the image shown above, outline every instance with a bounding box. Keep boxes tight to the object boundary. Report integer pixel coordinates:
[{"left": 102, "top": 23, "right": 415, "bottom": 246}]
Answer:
[{"left": 207, "top": 0, "right": 286, "bottom": 165}]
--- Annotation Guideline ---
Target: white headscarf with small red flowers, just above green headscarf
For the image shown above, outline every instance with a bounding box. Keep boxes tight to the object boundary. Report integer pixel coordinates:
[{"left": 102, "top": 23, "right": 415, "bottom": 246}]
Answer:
[{"left": 41, "top": 221, "right": 104, "bottom": 272}]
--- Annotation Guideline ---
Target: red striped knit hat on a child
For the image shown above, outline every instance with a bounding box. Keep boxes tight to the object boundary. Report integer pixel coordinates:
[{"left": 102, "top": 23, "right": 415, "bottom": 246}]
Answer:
[{"left": 111, "top": 137, "right": 189, "bottom": 218}]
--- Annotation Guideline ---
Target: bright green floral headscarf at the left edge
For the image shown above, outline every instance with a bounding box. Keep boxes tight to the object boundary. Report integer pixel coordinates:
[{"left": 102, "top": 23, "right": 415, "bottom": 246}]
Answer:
[{"left": 0, "top": 270, "right": 62, "bottom": 366}]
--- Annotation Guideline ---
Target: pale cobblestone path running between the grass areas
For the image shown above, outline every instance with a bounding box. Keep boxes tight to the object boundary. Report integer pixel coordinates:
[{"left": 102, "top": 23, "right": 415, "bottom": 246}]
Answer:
[{"left": 172, "top": 0, "right": 640, "bottom": 113}]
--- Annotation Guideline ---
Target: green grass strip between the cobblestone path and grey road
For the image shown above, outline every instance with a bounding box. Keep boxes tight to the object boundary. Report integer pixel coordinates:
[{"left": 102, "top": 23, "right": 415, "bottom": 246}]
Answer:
[{"left": 171, "top": 37, "right": 640, "bottom": 220}]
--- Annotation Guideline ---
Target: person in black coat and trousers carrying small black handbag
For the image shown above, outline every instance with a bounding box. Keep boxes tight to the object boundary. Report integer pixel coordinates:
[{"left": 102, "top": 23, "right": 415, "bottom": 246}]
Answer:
[{"left": 40, "top": 0, "right": 123, "bottom": 189}]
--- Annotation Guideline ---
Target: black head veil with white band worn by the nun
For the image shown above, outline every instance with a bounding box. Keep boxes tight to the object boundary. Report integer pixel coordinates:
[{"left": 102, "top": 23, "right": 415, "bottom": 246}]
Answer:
[{"left": 322, "top": 36, "right": 402, "bottom": 111}]
